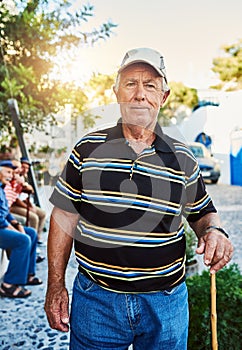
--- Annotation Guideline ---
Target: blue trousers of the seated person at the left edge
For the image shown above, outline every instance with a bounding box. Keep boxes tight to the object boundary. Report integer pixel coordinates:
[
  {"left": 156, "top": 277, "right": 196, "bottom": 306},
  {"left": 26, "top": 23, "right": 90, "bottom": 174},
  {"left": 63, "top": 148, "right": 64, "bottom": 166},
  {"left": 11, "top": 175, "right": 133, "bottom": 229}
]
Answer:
[{"left": 0, "top": 227, "right": 38, "bottom": 284}]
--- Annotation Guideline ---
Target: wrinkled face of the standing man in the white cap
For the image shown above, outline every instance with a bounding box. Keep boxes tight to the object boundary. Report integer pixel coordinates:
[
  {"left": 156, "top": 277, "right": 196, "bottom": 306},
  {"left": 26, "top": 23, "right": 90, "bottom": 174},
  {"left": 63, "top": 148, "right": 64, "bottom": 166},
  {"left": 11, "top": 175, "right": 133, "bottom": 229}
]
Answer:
[{"left": 114, "top": 63, "right": 166, "bottom": 130}]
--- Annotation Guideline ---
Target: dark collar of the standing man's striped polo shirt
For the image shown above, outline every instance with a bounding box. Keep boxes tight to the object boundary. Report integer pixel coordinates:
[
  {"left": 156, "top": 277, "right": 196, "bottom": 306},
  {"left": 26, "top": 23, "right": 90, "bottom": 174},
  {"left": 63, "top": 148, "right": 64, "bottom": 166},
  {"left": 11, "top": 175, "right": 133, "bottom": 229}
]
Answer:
[{"left": 106, "top": 118, "right": 175, "bottom": 153}]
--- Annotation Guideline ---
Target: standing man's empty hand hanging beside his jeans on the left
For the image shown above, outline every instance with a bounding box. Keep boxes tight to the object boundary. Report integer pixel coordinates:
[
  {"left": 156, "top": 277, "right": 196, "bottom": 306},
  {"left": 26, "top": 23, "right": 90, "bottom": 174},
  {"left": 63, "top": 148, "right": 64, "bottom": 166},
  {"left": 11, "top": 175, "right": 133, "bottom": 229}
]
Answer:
[{"left": 45, "top": 286, "right": 69, "bottom": 332}]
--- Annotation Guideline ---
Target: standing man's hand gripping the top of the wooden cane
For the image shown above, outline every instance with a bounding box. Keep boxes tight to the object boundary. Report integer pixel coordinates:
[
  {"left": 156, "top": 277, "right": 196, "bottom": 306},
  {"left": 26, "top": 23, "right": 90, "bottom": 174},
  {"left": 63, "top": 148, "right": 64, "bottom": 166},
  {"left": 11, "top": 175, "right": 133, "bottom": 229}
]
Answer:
[{"left": 196, "top": 229, "right": 234, "bottom": 273}]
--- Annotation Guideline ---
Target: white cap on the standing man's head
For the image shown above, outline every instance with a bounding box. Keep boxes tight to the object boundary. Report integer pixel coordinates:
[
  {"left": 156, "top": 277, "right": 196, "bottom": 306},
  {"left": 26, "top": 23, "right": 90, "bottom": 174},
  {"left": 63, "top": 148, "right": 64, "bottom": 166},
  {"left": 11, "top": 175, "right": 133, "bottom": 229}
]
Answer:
[{"left": 118, "top": 48, "right": 167, "bottom": 83}]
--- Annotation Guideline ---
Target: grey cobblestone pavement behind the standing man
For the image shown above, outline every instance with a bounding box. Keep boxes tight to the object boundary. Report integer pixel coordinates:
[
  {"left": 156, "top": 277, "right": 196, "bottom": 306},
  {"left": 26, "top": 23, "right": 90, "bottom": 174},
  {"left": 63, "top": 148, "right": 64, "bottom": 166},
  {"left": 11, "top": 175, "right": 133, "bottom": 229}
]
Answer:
[{"left": 0, "top": 184, "right": 242, "bottom": 350}]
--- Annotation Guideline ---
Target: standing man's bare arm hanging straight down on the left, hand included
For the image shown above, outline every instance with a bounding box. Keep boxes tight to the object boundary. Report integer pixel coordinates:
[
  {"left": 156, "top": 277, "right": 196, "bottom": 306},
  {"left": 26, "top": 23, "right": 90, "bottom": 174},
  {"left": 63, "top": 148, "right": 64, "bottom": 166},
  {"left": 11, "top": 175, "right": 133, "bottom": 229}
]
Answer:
[{"left": 45, "top": 208, "right": 79, "bottom": 332}]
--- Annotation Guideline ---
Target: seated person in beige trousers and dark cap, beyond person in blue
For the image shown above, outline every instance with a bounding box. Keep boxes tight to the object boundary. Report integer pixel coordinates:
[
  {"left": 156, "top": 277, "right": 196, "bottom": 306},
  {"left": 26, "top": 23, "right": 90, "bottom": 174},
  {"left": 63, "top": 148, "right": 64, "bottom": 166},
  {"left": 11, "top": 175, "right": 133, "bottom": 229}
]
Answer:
[{"left": 10, "top": 158, "right": 46, "bottom": 243}]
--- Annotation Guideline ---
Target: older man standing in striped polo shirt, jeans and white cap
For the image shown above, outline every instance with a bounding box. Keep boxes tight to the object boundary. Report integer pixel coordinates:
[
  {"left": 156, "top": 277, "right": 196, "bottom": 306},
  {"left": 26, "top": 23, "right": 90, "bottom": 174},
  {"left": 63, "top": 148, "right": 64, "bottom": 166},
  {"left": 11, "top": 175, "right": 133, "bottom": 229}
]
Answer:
[{"left": 45, "top": 48, "right": 233, "bottom": 350}]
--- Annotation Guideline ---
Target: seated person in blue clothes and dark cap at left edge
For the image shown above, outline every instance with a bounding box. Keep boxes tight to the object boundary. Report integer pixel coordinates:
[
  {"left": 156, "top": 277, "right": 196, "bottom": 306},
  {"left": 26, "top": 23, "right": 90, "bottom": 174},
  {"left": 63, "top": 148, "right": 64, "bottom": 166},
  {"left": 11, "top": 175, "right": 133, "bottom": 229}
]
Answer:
[{"left": 0, "top": 160, "right": 43, "bottom": 298}]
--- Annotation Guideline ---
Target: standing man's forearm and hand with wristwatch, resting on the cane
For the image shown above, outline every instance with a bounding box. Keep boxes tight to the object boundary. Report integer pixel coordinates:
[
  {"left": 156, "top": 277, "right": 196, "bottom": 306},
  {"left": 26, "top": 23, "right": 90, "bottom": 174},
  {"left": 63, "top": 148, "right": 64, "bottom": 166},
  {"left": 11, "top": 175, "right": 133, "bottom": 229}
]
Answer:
[{"left": 189, "top": 213, "right": 233, "bottom": 273}]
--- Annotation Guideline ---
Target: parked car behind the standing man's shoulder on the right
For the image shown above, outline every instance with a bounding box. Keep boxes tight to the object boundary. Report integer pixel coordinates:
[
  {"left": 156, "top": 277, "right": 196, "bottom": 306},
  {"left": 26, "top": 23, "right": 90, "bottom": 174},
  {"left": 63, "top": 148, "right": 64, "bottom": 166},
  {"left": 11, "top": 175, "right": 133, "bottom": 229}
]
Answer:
[{"left": 188, "top": 142, "right": 221, "bottom": 184}]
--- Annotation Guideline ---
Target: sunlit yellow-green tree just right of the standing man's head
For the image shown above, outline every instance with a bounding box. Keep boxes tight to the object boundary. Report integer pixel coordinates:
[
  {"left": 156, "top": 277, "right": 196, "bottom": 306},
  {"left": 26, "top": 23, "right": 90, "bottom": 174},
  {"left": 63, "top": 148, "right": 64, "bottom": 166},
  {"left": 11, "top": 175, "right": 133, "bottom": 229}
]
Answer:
[{"left": 158, "top": 82, "right": 198, "bottom": 126}]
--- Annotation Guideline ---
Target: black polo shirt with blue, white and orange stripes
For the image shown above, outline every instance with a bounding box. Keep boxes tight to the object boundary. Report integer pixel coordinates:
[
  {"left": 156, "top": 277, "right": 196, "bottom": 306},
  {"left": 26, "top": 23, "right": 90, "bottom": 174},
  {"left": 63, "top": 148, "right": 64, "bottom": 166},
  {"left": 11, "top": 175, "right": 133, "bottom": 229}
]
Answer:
[{"left": 50, "top": 122, "right": 216, "bottom": 293}]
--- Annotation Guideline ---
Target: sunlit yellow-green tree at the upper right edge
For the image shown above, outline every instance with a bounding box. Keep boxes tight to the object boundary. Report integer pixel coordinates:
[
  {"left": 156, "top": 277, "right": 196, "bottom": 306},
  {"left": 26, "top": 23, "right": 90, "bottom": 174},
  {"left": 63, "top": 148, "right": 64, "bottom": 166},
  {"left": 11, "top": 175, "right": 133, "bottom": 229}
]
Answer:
[{"left": 212, "top": 39, "right": 242, "bottom": 90}]
